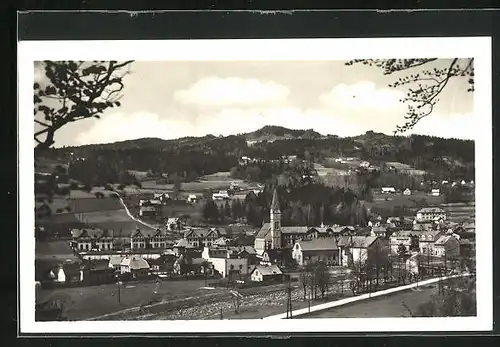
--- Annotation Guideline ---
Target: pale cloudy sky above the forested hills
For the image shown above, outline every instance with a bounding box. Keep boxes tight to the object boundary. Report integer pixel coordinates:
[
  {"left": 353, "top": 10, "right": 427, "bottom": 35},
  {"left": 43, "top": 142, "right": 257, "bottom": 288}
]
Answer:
[{"left": 35, "top": 60, "right": 474, "bottom": 147}]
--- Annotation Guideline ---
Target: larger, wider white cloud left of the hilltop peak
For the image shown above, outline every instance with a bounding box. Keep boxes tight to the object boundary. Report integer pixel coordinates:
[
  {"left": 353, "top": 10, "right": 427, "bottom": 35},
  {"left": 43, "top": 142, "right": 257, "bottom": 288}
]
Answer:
[{"left": 174, "top": 77, "right": 290, "bottom": 106}]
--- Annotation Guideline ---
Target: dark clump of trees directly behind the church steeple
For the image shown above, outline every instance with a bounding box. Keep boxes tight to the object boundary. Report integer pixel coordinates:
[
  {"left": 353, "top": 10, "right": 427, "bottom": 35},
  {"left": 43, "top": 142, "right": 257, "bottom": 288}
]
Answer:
[{"left": 203, "top": 184, "right": 368, "bottom": 226}]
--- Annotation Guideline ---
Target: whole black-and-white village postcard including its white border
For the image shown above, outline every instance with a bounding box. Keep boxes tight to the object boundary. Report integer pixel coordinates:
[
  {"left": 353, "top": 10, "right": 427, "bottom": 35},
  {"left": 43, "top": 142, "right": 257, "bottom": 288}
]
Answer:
[{"left": 19, "top": 37, "right": 493, "bottom": 332}]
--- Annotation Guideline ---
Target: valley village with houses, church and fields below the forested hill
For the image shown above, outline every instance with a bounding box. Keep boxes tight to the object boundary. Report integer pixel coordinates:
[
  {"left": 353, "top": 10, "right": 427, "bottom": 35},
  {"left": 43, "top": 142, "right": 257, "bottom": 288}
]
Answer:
[{"left": 35, "top": 157, "right": 475, "bottom": 320}]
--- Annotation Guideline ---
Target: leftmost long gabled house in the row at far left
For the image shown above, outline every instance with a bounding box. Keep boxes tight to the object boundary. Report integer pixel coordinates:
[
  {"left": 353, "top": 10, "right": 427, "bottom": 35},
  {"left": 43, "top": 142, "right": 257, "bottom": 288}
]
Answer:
[{"left": 71, "top": 228, "right": 114, "bottom": 251}]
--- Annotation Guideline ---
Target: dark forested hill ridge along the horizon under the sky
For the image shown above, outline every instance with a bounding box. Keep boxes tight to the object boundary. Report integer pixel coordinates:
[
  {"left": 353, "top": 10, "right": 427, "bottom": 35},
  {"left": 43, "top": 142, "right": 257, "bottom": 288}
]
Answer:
[{"left": 48, "top": 126, "right": 474, "bottom": 184}]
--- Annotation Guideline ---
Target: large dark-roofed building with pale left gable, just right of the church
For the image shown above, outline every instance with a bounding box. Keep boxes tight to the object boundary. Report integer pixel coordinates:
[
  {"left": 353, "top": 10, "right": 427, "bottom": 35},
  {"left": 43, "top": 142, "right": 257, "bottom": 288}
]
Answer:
[{"left": 292, "top": 237, "right": 339, "bottom": 266}]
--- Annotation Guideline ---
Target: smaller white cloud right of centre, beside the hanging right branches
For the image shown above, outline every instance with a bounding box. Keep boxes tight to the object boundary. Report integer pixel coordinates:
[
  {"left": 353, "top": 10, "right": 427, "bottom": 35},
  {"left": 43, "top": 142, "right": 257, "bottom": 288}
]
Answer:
[{"left": 320, "top": 81, "right": 404, "bottom": 109}]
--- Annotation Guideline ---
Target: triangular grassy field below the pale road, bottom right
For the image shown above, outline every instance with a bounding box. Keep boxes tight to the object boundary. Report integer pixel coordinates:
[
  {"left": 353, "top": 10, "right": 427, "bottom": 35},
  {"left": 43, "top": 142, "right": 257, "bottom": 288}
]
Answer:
[{"left": 297, "top": 286, "right": 437, "bottom": 318}]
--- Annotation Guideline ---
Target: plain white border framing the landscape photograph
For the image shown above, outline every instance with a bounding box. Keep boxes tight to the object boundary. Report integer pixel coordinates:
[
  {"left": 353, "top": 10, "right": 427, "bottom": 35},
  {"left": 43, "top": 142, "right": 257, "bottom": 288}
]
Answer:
[{"left": 18, "top": 37, "right": 493, "bottom": 333}]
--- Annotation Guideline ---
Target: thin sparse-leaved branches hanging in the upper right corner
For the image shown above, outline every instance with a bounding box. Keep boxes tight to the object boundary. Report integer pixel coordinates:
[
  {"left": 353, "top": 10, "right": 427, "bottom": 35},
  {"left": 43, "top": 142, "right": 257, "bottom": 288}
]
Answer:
[{"left": 346, "top": 58, "right": 474, "bottom": 133}]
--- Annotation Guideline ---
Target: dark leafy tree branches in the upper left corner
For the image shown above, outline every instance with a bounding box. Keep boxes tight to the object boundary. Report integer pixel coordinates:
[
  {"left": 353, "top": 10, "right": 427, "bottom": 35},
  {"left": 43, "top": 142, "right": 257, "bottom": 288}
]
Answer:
[{"left": 33, "top": 60, "right": 132, "bottom": 153}]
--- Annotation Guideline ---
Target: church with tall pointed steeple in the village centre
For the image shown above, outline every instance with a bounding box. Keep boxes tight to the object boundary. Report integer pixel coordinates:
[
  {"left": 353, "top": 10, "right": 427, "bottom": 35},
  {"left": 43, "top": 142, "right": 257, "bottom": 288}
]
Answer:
[{"left": 254, "top": 189, "right": 310, "bottom": 255}]
